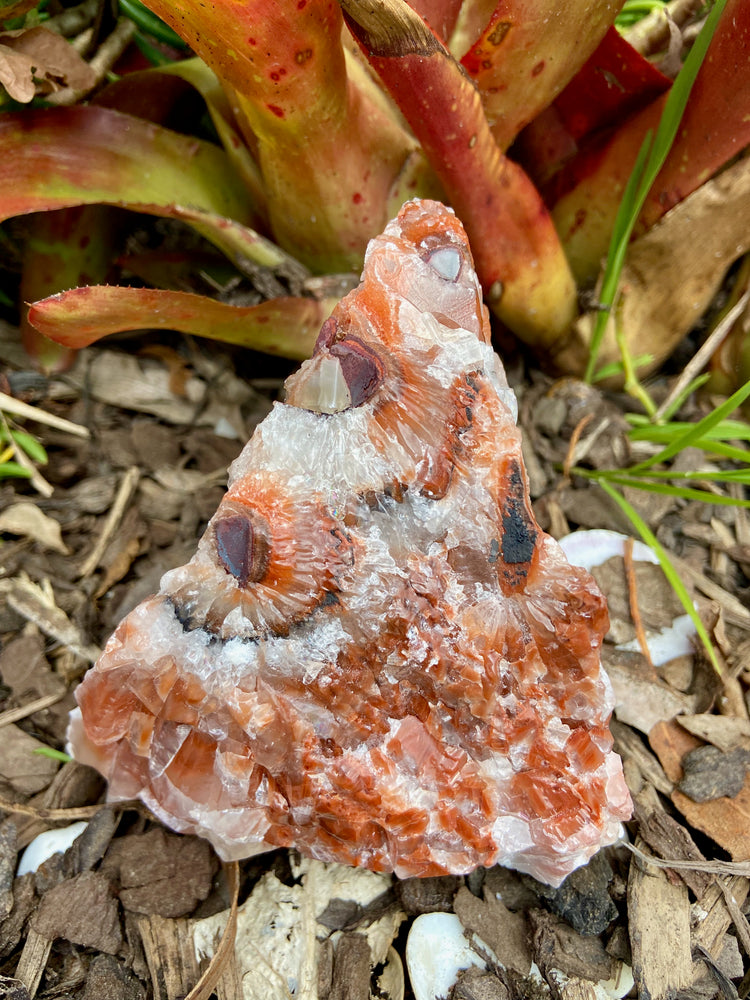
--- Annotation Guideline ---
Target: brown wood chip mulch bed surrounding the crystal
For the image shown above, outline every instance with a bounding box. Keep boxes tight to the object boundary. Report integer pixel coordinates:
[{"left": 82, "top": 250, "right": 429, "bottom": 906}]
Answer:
[{"left": 0, "top": 327, "right": 750, "bottom": 1000}]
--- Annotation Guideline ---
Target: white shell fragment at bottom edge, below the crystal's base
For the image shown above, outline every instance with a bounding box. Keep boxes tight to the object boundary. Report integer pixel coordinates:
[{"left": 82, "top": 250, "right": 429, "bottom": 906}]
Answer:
[{"left": 406, "top": 913, "right": 487, "bottom": 1000}]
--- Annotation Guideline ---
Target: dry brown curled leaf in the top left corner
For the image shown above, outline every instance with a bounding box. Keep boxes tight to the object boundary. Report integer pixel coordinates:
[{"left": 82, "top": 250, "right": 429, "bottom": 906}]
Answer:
[{"left": 0, "top": 26, "right": 96, "bottom": 104}]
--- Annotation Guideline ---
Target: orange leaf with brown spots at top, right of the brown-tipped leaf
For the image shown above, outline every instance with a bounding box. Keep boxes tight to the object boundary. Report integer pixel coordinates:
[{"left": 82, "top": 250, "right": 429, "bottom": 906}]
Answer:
[{"left": 461, "top": 0, "right": 622, "bottom": 149}]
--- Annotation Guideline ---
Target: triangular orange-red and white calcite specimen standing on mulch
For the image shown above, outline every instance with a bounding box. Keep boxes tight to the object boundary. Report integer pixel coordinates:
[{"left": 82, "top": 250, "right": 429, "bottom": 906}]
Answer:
[{"left": 70, "top": 201, "right": 631, "bottom": 884}]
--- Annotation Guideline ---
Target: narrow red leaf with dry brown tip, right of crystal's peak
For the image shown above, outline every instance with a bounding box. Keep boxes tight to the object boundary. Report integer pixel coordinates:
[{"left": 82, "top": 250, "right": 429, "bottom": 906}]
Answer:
[{"left": 341, "top": 0, "right": 576, "bottom": 347}]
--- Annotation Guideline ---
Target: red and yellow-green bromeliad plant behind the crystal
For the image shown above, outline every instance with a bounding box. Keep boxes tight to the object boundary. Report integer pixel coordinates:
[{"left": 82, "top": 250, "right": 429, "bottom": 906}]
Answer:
[{"left": 0, "top": 0, "right": 750, "bottom": 373}]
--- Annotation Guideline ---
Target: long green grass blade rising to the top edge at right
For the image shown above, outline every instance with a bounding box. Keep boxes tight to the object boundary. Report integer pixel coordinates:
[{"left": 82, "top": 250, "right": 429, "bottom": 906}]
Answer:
[{"left": 584, "top": 0, "right": 727, "bottom": 383}]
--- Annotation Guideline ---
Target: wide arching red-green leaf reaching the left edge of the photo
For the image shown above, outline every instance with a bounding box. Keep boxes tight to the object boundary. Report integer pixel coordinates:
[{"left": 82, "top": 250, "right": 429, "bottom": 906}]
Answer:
[{"left": 0, "top": 106, "right": 299, "bottom": 278}]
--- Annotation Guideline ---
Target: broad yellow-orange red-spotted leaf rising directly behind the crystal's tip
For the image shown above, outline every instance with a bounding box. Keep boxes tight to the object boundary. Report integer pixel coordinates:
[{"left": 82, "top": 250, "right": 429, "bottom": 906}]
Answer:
[{"left": 137, "top": 0, "right": 435, "bottom": 273}]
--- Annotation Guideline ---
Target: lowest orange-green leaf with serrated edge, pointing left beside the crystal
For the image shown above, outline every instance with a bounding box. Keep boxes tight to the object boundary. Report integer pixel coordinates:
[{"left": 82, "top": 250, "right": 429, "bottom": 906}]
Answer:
[{"left": 29, "top": 285, "right": 336, "bottom": 359}]
